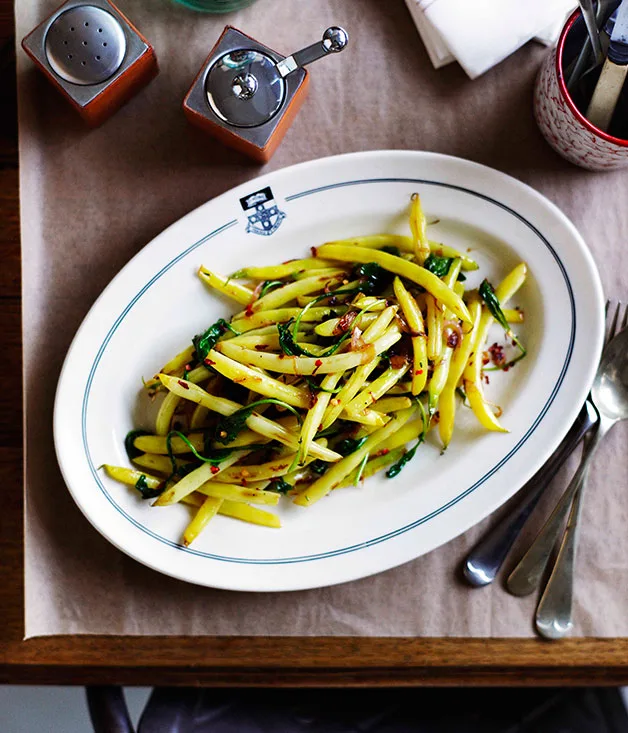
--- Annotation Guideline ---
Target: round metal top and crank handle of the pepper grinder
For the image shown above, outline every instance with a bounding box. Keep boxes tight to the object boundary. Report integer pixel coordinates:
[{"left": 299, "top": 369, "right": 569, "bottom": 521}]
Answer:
[{"left": 205, "top": 26, "right": 349, "bottom": 128}]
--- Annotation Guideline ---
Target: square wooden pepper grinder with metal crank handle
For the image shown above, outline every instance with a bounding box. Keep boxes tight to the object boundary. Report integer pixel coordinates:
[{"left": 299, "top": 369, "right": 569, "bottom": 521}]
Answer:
[{"left": 183, "top": 26, "right": 349, "bottom": 163}]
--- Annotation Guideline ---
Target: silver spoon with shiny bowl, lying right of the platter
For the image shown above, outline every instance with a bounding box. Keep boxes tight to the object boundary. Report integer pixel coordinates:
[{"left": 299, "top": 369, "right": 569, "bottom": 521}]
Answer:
[{"left": 536, "top": 318, "right": 628, "bottom": 639}]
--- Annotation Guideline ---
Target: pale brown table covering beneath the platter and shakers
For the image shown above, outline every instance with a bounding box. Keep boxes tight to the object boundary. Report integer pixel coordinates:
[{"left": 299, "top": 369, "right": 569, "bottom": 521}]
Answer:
[{"left": 16, "top": 0, "right": 628, "bottom": 637}]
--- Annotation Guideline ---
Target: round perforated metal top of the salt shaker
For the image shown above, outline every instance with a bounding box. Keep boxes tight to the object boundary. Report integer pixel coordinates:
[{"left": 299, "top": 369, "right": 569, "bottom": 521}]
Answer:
[{"left": 45, "top": 5, "right": 127, "bottom": 86}]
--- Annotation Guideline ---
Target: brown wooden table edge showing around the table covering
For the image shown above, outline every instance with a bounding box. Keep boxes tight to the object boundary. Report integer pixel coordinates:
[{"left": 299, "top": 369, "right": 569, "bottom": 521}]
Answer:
[{"left": 0, "top": 7, "right": 628, "bottom": 687}]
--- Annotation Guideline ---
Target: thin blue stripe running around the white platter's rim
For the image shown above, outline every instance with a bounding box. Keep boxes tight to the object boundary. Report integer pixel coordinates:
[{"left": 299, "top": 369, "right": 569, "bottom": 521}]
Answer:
[{"left": 81, "top": 178, "right": 576, "bottom": 565}]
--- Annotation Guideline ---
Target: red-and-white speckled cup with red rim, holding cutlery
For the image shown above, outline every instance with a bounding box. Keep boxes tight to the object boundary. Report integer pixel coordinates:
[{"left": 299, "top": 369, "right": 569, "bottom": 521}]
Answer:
[{"left": 534, "top": 10, "right": 628, "bottom": 171}]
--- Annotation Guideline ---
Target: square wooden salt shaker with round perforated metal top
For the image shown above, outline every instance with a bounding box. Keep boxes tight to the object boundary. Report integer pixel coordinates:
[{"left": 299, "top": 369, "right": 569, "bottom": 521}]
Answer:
[{"left": 22, "top": 0, "right": 158, "bottom": 126}]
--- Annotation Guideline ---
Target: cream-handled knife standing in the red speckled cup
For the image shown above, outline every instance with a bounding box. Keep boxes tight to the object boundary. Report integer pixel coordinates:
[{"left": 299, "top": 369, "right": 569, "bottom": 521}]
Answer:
[{"left": 586, "top": 0, "right": 628, "bottom": 132}]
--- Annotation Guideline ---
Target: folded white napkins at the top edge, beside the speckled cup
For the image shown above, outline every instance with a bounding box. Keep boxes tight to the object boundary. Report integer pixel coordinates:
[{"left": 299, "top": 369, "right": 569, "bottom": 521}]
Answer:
[{"left": 406, "top": 0, "right": 575, "bottom": 79}]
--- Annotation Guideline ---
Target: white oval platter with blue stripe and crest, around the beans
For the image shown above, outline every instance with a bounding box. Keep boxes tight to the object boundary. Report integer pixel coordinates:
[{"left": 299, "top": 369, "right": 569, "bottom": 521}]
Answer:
[{"left": 54, "top": 151, "right": 604, "bottom": 591}]
